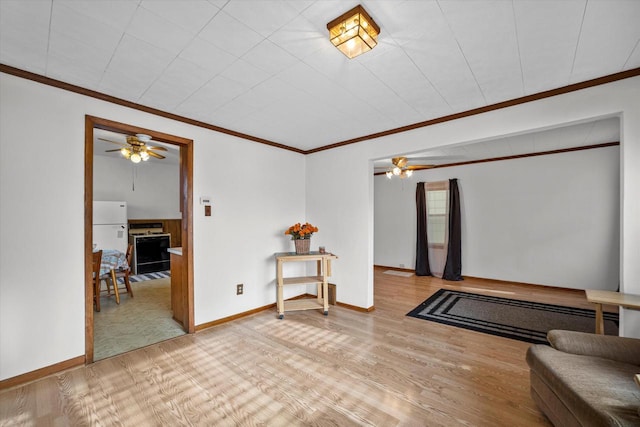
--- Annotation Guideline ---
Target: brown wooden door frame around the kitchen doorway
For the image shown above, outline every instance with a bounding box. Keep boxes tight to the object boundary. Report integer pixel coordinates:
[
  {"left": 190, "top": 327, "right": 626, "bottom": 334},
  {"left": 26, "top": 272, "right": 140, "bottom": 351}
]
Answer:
[{"left": 84, "top": 115, "right": 195, "bottom": 363}]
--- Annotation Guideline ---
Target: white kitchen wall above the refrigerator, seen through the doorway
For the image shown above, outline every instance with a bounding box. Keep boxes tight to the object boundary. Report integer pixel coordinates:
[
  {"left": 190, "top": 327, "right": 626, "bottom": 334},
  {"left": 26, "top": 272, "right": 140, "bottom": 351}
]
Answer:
[{"left": 93, "top": 156, "right": 182, "bottom": 219}]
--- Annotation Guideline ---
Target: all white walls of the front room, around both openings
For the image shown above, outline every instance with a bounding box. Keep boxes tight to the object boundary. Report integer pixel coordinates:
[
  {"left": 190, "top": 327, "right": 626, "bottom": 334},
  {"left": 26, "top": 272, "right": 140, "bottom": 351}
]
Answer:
[{"left": 0, "top": 74, "right": 640, "bottom": 379}]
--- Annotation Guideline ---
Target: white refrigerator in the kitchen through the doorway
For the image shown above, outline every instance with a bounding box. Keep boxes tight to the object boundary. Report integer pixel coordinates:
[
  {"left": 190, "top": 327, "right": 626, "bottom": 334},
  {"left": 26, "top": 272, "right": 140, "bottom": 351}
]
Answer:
[{"left": 93, "top": 200, "right": 129, "bottom": 253}]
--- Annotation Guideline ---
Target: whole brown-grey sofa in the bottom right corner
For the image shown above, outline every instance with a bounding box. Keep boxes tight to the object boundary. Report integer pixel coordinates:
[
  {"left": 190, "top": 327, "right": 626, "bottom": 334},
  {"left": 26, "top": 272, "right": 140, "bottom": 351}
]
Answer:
[{"left": 527, "top": 330, "right": 640, "bottom": 427}]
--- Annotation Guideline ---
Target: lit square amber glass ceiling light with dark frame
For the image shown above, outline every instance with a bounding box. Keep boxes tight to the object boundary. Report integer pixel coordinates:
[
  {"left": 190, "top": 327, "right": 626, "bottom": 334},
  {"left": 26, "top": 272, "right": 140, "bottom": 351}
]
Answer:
[{"left": 327, "top": 5, "right": 380, "bottom": 59}]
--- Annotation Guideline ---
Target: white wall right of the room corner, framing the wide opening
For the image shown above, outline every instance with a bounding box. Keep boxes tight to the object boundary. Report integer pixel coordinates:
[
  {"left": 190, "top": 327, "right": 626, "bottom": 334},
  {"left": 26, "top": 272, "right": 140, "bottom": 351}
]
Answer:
[{"left": 307, "top": 77, "right": 640, "bottom": 337}]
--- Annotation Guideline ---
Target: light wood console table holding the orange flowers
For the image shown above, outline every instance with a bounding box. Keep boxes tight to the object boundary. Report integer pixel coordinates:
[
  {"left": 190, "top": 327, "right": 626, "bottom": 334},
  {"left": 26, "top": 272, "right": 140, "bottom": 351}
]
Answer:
[{"left": 275, "top": 252, "right": 338, "bottom": 319}]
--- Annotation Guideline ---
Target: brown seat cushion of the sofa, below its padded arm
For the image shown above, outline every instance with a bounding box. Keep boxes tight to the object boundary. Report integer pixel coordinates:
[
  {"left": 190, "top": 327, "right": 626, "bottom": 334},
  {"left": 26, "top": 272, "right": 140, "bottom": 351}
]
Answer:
[{"left": 527, "top": 345, "right": 640, "bottom": 427}]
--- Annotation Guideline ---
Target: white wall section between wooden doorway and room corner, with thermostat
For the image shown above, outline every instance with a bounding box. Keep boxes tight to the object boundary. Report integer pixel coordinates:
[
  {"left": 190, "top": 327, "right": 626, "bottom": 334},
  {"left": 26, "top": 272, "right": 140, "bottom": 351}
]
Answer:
[{"left": 193, "top": 130, "right": 306, "bottom": 325}]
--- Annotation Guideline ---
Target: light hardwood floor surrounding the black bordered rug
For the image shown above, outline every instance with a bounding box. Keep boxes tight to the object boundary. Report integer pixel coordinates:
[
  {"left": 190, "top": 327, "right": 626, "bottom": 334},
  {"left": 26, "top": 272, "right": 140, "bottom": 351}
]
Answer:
[{"left": 0, "top": 268, "right": 591, "bottom": 427}]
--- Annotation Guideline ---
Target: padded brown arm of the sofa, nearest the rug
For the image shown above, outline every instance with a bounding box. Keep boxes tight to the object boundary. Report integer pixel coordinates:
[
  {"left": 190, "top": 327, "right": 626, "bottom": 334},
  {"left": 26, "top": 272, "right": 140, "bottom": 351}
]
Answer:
[{"left": 547, "top": 330, "right": 640, "bottom": 365}]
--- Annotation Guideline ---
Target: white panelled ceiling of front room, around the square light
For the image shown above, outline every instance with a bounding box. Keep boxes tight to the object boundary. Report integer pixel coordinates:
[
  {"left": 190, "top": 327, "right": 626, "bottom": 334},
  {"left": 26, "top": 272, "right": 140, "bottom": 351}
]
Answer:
[{"left": 0, "top": 0, "right": 640, "bottom": 155}]
